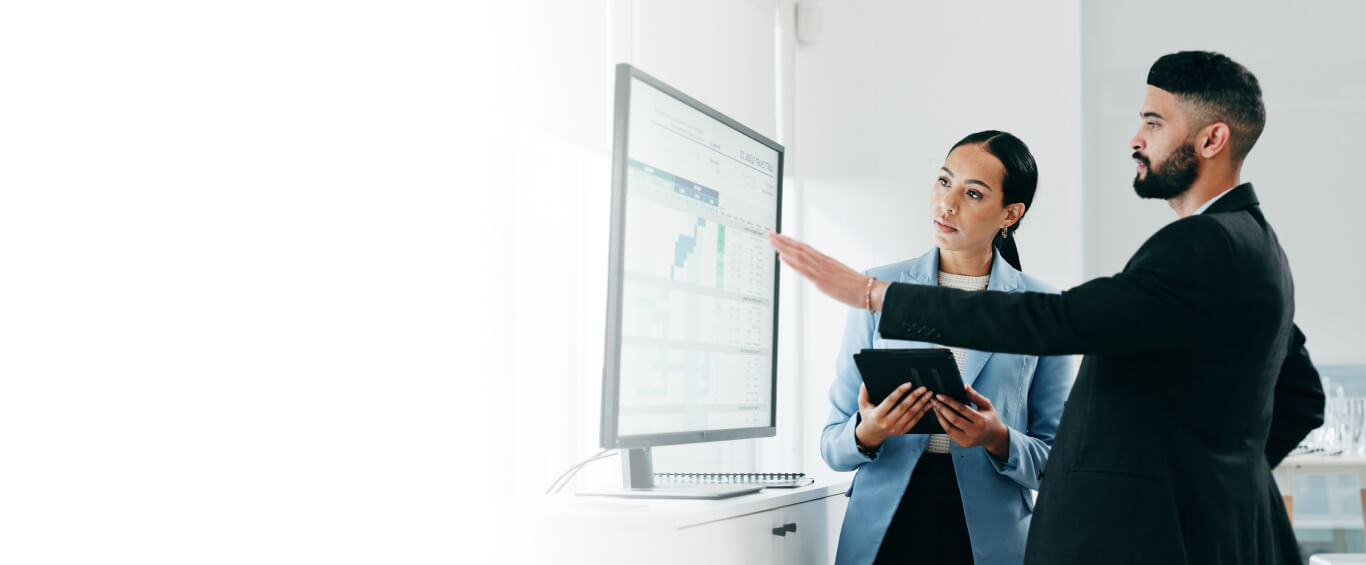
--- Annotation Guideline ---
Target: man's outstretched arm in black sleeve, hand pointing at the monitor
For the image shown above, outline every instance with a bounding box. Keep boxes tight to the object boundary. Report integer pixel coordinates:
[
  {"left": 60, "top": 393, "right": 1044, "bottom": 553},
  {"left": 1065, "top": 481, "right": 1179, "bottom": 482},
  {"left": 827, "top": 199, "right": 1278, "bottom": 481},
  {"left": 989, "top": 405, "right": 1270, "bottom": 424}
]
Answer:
[{"left": 770, "top": 220, "right": 1236, "bottom": 355}]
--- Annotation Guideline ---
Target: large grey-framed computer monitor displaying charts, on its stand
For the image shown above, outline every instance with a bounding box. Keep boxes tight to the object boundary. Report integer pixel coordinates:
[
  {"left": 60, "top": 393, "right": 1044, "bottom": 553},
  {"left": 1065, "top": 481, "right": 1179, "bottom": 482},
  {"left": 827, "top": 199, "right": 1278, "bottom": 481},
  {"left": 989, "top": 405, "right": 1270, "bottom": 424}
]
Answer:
[{"left": 601, "top": 64, "right": 783, "bottom": 495}]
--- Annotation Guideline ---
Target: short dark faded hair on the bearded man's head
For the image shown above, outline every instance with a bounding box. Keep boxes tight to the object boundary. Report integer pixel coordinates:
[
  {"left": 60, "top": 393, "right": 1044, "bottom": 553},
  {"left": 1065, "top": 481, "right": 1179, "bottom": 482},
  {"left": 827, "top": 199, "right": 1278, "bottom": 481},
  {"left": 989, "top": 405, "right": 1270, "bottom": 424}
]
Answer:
[{"left": 1147, "top": 50, "right": 1266, "bottom": 162}]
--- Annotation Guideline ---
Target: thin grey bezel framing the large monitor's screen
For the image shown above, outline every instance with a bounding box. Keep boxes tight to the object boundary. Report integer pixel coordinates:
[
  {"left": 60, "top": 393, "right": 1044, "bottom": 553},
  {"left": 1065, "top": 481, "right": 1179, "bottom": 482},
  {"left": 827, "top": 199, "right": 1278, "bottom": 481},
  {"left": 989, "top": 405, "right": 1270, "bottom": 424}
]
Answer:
[{"left": 600, "top": 63, "right": 785, "bottom": 449}]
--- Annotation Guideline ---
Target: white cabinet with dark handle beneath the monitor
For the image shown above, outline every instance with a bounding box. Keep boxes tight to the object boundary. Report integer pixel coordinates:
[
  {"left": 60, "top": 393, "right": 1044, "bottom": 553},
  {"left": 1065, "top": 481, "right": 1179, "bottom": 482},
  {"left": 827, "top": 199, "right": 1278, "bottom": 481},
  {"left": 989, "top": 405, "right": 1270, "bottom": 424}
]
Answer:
[{"left": 518, "top": 478, "right": 850, "bottom": 565}]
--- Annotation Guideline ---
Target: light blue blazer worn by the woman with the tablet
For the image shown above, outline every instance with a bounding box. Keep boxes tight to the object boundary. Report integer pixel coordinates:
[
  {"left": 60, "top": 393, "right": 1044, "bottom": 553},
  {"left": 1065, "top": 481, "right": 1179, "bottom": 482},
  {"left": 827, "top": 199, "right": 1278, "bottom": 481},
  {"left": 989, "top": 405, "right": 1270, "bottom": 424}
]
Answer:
[{"left": 821, "top": 247, "right": 1075, "bottom": 565}]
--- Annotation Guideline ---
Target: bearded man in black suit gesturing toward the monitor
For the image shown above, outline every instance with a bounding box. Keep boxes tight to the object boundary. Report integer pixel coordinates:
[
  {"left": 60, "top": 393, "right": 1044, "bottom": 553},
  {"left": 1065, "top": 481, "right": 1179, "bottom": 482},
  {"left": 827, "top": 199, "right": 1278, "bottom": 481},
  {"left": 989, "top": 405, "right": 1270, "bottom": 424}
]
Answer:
[{"left": 770, "top": 52, "right": 1324, "bottom": 565}]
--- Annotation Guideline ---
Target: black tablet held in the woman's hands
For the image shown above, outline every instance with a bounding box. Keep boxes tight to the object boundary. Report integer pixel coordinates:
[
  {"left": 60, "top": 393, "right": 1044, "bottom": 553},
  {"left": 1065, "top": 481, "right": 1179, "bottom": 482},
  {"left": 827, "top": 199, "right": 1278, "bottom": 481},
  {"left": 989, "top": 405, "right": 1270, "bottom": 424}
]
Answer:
[{"left": 854, "top": 348, "right": 968, "bottom": 434}]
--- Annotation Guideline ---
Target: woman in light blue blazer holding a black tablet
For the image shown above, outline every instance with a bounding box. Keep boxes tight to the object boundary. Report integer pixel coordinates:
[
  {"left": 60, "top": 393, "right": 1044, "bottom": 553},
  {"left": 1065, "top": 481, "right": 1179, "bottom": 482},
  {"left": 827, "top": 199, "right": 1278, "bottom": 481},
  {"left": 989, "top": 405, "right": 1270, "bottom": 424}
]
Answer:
[{"left": 821, "top": 131, "right": 1074, "bottom": 565}]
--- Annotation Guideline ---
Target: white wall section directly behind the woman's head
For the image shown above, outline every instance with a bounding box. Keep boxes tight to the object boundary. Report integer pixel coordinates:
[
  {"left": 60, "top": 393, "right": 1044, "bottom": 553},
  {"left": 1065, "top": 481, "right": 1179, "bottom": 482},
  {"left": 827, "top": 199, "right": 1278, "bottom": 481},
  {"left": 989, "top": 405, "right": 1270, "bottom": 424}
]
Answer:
[{"left": 795, "top": 0, "right": 1082, "bottom": 477}]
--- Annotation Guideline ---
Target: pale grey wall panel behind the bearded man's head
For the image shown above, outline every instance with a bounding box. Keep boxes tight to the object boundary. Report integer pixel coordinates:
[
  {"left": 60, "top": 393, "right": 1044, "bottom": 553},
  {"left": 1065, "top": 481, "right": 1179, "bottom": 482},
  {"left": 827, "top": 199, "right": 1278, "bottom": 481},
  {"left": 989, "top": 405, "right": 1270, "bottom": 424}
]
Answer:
[{"left": 1082, "top": 0, "right": 1366, "bottom": 363}]
